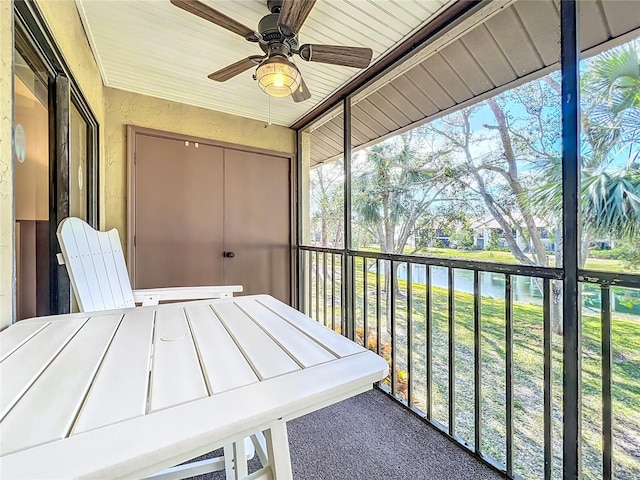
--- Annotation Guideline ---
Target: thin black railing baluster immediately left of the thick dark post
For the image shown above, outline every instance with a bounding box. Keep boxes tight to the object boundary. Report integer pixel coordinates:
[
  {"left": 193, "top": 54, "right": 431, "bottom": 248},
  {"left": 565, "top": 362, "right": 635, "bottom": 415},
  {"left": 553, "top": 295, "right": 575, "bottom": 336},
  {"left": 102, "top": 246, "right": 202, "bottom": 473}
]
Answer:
[{"left": 542, "top": 278, "right": 553, "bottom": 480}]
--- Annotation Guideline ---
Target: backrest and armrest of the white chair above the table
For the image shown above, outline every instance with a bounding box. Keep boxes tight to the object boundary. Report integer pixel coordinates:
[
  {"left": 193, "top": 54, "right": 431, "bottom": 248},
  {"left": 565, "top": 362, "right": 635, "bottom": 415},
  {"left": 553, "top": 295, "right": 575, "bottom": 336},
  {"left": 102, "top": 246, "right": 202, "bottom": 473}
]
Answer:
[{"left": 57, "top": 217, "right": 242, "bottom": 312}]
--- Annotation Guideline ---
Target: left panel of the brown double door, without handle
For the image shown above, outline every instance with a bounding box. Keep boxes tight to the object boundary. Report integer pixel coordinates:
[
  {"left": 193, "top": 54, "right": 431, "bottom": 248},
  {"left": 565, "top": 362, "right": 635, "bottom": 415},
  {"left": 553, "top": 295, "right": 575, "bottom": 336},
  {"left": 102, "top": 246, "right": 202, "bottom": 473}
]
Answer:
[{"left": 130, "top": 133, "right": 224, "bottom": 288}]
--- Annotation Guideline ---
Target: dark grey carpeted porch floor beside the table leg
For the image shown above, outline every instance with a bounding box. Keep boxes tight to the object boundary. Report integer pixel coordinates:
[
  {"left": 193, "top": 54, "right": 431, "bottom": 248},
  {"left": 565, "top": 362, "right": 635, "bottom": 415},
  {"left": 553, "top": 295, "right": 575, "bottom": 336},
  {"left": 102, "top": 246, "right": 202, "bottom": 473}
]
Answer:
[{"left": 196, "top": 390, "right": 504, "bottom": 480}]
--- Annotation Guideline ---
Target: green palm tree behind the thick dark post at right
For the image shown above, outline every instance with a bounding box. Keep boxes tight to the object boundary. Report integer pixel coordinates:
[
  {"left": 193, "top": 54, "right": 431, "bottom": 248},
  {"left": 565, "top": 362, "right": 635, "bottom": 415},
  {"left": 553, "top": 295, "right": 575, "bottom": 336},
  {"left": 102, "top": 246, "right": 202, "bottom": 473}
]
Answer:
[{"left": 528, "top": 41, "right": 640, "bottom": 334}]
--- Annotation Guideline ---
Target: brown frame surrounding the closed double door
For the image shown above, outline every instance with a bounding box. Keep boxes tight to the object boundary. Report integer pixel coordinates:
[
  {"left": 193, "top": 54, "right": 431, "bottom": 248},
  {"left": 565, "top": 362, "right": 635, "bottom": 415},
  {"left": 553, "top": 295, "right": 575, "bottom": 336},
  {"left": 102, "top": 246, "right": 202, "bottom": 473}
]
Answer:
[{"left": 125, "top": 125, "right": 298, "bottom": 304}]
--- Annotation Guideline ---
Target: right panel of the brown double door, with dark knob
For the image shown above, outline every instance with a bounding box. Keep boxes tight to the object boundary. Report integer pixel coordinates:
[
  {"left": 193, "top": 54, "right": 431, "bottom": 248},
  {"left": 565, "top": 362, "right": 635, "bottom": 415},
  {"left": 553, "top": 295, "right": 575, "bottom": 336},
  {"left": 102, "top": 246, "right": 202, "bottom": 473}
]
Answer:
[{"left": 224, "top": 149, "right": 291, "bottom": 303}]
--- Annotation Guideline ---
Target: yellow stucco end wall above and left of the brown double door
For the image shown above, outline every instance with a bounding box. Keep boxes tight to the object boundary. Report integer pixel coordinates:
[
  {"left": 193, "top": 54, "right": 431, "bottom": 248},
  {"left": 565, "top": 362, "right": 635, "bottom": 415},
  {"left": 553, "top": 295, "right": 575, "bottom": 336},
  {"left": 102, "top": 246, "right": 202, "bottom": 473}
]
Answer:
[{"left": 102, "top": 88, "right": 295, "bottom": 242}]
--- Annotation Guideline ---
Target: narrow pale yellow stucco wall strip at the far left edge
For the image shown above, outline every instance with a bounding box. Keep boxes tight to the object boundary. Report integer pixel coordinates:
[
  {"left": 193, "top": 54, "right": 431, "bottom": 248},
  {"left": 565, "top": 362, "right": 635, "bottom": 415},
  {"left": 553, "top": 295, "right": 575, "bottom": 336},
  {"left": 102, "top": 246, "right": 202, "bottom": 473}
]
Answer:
[{"left": 0, "top": 0, "right": 15, "bottom": 330}]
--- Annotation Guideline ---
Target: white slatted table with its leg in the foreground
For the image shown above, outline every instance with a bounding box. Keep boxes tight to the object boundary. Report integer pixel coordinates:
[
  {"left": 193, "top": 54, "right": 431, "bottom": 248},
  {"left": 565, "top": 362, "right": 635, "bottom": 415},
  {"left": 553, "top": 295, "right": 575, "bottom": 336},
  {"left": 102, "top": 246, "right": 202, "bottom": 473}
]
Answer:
[{"left": 0, "top": 295, "right": 387, "bottom": 479}]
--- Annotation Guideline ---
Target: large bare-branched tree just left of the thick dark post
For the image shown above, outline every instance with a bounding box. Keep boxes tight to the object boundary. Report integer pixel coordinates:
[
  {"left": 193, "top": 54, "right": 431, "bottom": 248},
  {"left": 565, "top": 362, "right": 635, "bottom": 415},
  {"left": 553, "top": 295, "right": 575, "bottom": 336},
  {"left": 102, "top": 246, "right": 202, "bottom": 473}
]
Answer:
[{"left": 428, "top": 89, "right": 562, "bottom": 330}]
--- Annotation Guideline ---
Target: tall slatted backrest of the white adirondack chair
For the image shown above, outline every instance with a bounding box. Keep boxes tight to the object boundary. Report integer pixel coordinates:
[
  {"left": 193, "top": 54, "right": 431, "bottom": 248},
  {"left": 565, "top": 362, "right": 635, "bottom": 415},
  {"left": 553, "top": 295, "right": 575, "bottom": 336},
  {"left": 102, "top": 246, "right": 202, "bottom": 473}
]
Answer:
[{"left": 57, "top": 217, "right": 135, "bottom": 312}]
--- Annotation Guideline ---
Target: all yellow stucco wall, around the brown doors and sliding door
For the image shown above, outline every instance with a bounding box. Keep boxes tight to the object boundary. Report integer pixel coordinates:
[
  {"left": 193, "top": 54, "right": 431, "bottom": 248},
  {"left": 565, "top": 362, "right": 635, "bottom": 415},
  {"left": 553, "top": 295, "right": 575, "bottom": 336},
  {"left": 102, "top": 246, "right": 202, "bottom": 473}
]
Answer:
[{"left": 0, "top": 0, "right": 295, "bottom": 329}]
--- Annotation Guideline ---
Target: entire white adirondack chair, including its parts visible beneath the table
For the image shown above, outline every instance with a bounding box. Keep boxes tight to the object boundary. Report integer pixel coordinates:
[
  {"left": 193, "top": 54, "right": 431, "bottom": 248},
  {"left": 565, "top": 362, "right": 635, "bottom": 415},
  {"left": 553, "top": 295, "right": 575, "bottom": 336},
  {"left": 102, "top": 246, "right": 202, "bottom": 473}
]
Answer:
[{"left": 57, "top": 217, "right": 266, "bottom": 480}]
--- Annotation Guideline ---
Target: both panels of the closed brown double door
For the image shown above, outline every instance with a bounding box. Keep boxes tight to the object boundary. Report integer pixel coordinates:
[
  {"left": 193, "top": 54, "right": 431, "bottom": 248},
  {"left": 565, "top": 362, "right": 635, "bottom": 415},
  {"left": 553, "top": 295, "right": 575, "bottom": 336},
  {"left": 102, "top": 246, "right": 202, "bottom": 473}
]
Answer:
[{"left": 130, "top": 132, "right": 291, "bottom": 303}]
